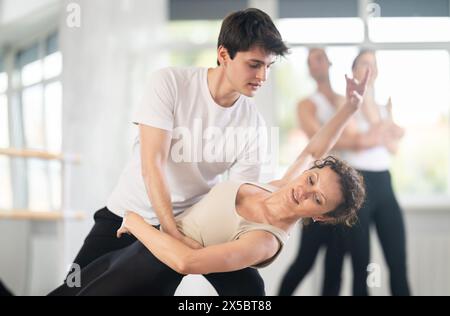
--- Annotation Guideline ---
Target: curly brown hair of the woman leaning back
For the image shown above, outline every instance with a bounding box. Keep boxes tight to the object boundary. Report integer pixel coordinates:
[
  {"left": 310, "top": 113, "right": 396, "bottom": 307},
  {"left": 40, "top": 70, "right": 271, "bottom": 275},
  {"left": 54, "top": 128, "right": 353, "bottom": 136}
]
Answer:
[{"left": 303, "top": 156, "right": 366, "bottom": 227}]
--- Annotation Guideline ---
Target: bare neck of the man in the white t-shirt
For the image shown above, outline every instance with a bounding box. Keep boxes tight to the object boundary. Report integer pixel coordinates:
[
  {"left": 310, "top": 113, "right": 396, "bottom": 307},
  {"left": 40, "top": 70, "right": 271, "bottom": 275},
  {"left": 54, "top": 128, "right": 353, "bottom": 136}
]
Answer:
[{"left": 208, "top": 67, "right": 240, "bottom": 108}]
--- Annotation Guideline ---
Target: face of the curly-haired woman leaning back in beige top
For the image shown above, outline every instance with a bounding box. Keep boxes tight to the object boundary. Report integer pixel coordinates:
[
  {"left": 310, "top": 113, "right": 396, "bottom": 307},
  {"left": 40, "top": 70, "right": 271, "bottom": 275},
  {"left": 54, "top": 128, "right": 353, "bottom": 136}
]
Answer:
[{"left": 277, "top": 167, "right": 343, "bottom": 221}]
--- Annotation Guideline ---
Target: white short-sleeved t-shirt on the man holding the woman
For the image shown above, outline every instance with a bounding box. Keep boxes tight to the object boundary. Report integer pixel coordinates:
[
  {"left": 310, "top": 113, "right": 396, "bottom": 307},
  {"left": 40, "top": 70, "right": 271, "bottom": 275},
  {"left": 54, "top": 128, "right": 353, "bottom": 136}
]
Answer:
[{"left": 107, "top": 68, "right": 267, "bottom": 225}]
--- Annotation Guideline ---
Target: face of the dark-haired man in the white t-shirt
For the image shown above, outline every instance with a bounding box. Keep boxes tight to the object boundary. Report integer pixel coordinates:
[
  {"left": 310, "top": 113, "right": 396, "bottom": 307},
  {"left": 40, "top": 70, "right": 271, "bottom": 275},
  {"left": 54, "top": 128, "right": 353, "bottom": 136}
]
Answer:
[{"left": 223, "top": 47, "right": 276, "bottom": 97}]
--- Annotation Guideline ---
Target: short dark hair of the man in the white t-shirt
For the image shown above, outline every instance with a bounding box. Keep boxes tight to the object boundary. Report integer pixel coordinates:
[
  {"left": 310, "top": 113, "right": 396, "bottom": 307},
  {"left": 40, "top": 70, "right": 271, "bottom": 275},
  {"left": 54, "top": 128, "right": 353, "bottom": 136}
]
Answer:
[{"left": 217, "top": 8, "right": 289, "bottom": 65}]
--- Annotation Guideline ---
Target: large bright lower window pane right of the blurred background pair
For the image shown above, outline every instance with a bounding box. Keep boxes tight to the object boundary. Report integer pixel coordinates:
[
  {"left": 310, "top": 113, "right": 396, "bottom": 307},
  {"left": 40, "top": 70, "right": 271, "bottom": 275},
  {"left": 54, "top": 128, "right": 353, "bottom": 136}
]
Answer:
[{"left": 376, "top": 50, "right": 450, "bottom": 195}]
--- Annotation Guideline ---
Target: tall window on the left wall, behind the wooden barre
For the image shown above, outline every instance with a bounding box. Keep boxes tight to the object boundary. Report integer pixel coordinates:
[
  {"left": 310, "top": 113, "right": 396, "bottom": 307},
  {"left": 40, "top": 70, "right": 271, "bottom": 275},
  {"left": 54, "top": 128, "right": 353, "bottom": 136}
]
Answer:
[{"left": 0, "top": 33, "right": 62, "bottom": 211}]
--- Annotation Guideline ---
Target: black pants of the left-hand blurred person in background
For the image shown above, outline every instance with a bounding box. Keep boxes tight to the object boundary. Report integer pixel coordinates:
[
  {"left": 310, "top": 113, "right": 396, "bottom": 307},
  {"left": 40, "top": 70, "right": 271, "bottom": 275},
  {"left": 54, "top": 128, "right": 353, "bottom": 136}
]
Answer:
[{"left": 278, "top": 223, "right": 345, "bottom": 296}]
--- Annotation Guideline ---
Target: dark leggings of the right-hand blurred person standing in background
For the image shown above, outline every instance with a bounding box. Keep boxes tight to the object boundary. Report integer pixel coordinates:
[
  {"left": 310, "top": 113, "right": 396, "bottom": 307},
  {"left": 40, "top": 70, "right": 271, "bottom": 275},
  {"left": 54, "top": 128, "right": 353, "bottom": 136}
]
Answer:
[{"left": 344, "top": 171, "right": 410, "bottom": 296}]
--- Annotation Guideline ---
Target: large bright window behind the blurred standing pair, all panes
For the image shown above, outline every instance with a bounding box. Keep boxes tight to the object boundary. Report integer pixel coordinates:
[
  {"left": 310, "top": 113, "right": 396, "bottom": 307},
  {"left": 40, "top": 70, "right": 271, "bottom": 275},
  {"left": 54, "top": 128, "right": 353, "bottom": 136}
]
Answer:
[{"left": 276, "top": 17, "right": 450, "bottom": 196}]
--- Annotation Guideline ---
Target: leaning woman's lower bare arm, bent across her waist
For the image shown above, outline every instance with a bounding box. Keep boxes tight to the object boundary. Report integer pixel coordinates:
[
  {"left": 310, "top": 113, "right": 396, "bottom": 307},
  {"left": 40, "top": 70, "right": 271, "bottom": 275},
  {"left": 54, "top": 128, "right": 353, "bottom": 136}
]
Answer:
[{"left": 117, "top": 212, "right": 280, "bottom": 274}]
